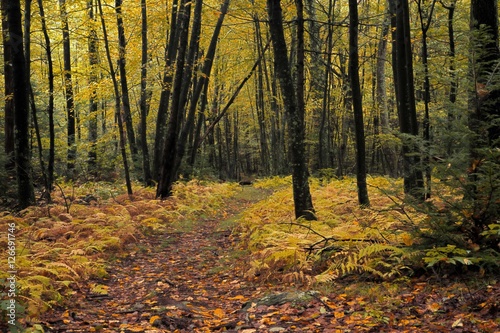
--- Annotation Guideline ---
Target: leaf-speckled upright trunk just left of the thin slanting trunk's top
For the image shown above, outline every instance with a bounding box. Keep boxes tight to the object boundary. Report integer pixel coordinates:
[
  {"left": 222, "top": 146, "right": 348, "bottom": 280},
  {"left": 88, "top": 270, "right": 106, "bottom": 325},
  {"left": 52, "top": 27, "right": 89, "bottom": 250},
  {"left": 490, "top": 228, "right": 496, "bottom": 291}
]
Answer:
[{"left": 87, "top": 0, "right": 99, "bottom": 172}]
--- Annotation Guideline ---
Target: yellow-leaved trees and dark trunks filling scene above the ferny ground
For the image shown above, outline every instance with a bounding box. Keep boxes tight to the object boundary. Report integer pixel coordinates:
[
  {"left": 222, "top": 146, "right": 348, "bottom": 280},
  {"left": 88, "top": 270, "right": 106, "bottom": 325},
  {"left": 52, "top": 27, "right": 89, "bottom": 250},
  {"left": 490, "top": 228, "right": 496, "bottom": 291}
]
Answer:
[{"left": 0, "top": 0, "right": 500, "bottom": 249}]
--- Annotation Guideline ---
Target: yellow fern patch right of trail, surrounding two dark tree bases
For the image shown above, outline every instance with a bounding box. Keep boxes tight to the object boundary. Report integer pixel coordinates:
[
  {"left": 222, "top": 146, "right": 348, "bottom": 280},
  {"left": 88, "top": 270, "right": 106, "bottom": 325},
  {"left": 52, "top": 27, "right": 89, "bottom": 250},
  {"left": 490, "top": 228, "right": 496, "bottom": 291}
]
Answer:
[{"left": 240, "top": 177, "right": 425, "bottom": 282}]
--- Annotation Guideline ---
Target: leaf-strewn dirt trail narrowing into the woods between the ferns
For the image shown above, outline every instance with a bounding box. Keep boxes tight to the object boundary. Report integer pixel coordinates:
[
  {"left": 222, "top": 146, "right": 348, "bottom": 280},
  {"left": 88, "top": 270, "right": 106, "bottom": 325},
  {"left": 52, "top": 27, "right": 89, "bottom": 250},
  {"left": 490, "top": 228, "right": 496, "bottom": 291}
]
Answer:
[{"left": 42, "top": 187, "right": 284, "bottom": 332}]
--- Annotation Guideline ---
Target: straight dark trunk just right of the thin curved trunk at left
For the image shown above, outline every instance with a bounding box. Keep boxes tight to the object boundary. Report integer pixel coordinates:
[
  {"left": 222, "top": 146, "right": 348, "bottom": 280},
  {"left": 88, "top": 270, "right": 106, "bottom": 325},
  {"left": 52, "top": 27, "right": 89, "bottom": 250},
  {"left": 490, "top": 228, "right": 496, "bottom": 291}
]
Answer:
[{"left": 59, "top": 0, "right": 76, "bottom": 178}]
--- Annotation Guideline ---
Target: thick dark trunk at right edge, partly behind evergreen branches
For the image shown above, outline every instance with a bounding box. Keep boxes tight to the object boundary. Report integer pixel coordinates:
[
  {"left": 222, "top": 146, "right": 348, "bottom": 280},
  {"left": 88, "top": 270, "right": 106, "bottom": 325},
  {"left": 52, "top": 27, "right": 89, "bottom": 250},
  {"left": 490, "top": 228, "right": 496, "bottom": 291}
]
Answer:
[{"left": 464, "top": 0, "right": 500, "bottom": 243}]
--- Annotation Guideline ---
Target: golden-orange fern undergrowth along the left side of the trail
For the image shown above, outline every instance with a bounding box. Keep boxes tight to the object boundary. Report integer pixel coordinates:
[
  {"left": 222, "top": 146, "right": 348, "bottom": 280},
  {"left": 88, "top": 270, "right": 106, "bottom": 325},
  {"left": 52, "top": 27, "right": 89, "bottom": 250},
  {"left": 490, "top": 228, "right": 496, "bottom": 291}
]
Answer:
[{"left": 0, "top": 180, "right": 238, "bottom": 320}]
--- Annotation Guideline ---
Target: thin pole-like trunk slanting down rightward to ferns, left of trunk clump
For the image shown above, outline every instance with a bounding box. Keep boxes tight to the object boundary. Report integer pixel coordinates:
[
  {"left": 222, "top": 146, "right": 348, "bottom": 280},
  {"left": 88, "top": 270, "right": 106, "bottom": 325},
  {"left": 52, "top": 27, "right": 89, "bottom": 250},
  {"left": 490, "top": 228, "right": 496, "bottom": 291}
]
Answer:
[{"left": 97, "top": 0, "right": 132, "bottom": 195}]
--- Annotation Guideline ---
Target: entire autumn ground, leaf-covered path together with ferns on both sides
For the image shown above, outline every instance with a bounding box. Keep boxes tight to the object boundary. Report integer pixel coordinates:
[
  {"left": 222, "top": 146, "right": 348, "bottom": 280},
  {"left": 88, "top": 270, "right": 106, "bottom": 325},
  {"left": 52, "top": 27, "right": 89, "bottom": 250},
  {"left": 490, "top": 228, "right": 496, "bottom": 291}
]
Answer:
[{"left": 0, "top": 178, "right": 500, "bottom": 333}]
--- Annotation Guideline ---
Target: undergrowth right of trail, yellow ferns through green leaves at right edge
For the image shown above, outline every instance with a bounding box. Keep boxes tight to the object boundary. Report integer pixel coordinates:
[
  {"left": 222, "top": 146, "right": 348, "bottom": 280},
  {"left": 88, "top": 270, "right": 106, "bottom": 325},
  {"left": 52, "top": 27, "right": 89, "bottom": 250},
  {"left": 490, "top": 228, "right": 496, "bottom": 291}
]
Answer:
[{"left": 240, "top": 177, "right": 498, "bottom": 284}]
